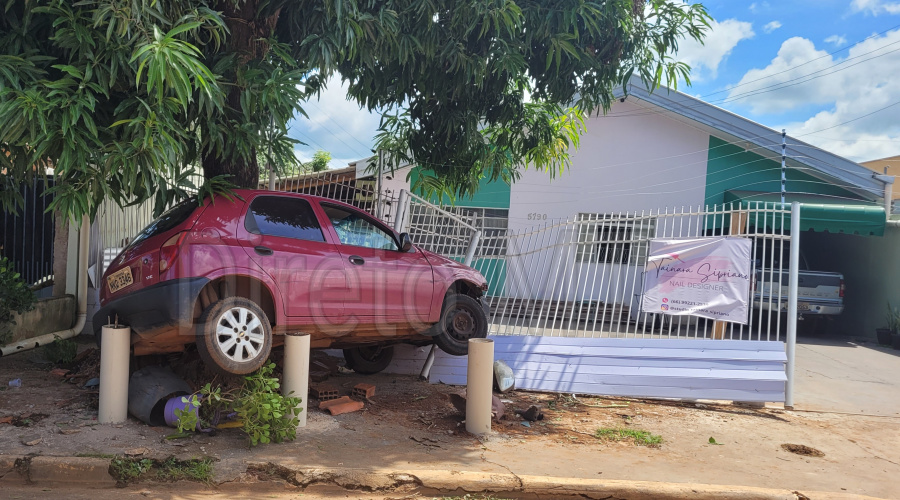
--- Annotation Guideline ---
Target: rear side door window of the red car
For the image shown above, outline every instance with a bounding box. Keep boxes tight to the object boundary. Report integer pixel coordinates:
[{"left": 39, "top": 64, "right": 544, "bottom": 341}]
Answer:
[{"left": 244, "top": 196, "right": 325, "bottom": 242}]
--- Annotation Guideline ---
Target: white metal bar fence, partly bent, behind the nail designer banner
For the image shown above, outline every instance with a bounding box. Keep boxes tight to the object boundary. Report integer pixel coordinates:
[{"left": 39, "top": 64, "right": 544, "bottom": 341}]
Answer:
[{"left": 398, "top": 192, "right": 790, "bottom": 340}]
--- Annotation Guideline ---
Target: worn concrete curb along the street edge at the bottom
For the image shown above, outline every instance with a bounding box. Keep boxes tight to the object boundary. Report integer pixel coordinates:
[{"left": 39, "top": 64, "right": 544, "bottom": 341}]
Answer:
[{"left": 0, "top": 456, "right": 879, "bottom": 500}]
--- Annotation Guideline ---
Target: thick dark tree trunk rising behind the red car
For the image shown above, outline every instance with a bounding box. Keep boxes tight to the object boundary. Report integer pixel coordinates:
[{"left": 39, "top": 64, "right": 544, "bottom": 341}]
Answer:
[{"left": 202, "top": 0, "right": 280, "bottom": 189}]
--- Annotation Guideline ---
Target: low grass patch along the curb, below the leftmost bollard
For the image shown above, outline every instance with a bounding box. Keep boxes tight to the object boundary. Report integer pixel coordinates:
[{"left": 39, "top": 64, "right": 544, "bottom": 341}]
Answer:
[{"left": 109, "top": 457, "right": 213, "bottom": 483}]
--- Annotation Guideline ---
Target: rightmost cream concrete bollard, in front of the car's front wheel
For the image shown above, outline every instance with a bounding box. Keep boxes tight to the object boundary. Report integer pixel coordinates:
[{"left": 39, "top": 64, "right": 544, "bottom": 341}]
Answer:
[{"left": 466, "top": 339, "right": 494, "bottom": 434}]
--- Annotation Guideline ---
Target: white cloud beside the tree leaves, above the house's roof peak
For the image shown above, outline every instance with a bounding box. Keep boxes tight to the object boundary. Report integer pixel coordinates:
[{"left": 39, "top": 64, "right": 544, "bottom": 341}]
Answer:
[{"left": 676, "top": 19, "right": 755, "bottom": 80}]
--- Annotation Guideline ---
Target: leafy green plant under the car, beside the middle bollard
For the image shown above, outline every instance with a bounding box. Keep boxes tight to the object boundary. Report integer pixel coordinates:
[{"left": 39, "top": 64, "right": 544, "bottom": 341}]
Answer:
[{"left": 175, "top": 363, "right": 301, "bottom": 446}]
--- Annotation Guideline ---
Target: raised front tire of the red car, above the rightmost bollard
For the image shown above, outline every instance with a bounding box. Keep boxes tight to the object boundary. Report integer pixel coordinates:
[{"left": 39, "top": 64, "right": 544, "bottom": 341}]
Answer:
[{"left": 434, "top": 293, "right": 487, "bottom": 356}]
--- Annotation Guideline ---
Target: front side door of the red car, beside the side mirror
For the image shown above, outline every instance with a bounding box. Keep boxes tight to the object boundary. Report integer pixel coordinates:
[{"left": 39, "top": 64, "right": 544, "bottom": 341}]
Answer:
[{"left": 321, "top": 203, "right": 434, "bottom": 326}]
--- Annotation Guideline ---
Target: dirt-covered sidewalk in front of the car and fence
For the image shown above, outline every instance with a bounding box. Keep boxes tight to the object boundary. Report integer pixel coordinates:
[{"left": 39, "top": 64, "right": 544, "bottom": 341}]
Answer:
[{"left": 0, "top": 338, "right": 900, "bottom": 498}]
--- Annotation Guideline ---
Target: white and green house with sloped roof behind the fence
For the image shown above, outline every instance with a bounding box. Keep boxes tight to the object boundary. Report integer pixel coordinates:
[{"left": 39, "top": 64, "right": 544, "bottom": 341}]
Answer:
[{"left": 357, "top": 80, "right": 900, "bottom": 342}]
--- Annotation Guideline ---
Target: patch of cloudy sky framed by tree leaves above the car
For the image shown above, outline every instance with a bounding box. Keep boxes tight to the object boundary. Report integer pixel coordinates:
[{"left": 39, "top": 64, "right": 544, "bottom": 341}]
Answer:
[{"left": 290, "top": 77, "right": 381, "bottom": 168}]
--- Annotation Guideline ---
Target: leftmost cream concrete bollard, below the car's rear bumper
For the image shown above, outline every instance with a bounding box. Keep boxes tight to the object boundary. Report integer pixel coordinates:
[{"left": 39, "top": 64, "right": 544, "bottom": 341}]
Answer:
[{"left": 97, "top": 325, "right": 131, "bottom": 424}]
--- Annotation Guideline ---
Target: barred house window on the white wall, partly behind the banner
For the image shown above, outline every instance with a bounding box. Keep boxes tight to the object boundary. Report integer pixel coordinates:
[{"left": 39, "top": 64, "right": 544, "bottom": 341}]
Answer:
[{"left": 576, "top": 214, "right": 656, "bottom": 265}]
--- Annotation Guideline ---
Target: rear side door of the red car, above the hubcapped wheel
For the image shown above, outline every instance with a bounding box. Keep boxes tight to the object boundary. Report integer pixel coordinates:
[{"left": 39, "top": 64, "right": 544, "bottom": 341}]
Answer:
[{"left": 237, "top": 194, "right": 346, "bottom": 321}]
